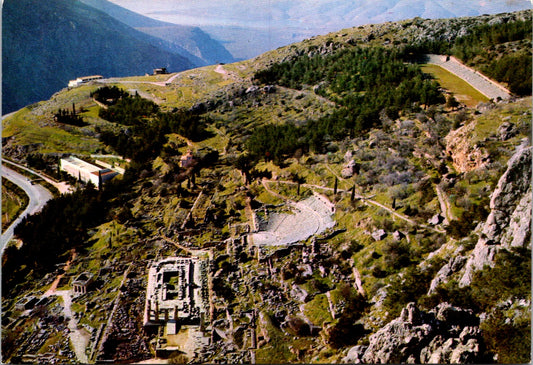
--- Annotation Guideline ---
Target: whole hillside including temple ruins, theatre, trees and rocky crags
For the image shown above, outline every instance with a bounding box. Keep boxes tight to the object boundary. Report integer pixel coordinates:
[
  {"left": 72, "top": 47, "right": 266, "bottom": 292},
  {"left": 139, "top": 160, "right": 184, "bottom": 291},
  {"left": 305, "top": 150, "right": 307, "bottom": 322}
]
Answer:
[{"left": 2, "top": 11, "right": 532, "bottom": 363}]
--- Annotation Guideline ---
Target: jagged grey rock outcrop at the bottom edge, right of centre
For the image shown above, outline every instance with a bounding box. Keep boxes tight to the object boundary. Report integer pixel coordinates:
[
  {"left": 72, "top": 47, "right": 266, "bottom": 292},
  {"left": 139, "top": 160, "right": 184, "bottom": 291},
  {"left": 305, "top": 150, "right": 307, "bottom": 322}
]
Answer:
[{"left": 343, "top": 303, "right": 483, "bottom": 364}]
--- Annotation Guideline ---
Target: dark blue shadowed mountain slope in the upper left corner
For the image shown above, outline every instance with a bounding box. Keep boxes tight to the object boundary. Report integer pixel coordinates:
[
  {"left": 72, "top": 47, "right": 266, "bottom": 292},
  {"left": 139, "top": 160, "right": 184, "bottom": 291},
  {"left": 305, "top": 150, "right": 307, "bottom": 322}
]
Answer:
[{"left": 2, "top": 0, "right": 196, "bottom": 114}]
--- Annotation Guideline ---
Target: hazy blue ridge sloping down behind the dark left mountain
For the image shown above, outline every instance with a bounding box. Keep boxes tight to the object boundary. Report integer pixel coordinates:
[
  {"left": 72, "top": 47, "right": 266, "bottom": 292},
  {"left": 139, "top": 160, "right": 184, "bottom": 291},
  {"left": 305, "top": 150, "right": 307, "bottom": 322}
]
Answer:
[{"left": 77, "top": 0, "right": 234, "bottom": 65}]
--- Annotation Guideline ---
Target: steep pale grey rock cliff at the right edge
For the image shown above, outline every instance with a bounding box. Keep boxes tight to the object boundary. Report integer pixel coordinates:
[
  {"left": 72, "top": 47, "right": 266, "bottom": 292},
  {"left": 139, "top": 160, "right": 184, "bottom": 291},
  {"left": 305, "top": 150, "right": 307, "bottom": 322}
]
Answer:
[{"left": 459, "top": 145, "right": 531, "bottom": 286}]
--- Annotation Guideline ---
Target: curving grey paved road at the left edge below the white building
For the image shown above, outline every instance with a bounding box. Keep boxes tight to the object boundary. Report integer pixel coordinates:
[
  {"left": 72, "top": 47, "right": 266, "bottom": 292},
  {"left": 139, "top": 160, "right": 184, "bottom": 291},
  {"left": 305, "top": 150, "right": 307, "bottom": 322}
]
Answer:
[{"left": 0, "top": 165, "right": 52, "bottom": 253}]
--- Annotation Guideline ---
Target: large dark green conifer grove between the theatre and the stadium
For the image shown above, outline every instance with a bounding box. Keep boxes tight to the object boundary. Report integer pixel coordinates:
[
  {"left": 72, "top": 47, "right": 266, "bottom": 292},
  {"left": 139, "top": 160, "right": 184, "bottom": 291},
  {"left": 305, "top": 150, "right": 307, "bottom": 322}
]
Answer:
[{"left": 247, "top": 47, "right": 444, "bottom": 161}]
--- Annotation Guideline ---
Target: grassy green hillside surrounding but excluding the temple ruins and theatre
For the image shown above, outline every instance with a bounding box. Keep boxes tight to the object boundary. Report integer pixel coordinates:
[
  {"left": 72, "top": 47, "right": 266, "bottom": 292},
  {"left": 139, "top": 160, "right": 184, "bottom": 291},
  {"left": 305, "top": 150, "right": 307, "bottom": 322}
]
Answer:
[{"left": 2, "top": 9, "right": 532, "bottom": 363}]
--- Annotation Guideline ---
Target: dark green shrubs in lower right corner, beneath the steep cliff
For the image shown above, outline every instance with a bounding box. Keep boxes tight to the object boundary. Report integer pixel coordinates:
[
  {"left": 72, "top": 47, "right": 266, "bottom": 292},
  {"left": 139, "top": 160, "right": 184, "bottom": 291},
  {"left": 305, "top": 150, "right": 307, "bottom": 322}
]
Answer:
[{"left": 420, "top": 248, "right": 531, "bottom": 363}]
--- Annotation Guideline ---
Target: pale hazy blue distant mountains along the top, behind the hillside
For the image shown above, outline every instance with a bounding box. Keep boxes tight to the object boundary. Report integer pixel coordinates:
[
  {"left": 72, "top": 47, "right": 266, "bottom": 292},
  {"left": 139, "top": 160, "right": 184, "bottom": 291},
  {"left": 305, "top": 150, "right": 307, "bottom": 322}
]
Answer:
[{"left": 106, "top": 0, "right": 531, "bottom": 59}]
